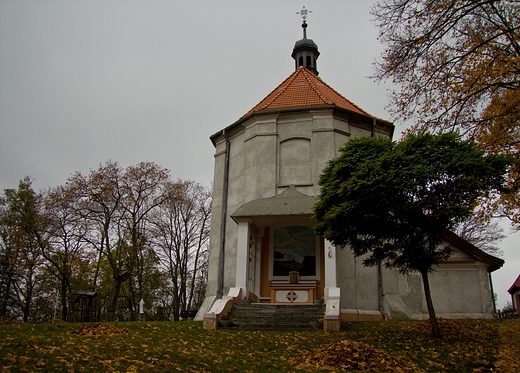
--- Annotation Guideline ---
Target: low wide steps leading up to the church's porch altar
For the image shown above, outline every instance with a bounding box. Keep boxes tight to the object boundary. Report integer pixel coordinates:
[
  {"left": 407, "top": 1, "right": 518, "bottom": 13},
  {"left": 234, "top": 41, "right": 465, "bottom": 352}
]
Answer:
[{"left": 229, "top": 303, "right": 325, "bottom": 330}]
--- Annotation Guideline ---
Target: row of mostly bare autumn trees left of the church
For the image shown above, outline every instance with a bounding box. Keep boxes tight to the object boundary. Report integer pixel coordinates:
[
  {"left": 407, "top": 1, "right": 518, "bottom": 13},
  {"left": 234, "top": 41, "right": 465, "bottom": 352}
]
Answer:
[{"left": 0, "top": 161, "right": 211, "bottom": 321}]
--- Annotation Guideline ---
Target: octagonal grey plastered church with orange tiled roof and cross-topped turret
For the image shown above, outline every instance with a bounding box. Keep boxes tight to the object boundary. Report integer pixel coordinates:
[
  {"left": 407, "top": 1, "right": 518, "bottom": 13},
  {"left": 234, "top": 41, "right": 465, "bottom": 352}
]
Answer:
[{"left": 196, "top": 11, "right": 503, "bottom": 330}]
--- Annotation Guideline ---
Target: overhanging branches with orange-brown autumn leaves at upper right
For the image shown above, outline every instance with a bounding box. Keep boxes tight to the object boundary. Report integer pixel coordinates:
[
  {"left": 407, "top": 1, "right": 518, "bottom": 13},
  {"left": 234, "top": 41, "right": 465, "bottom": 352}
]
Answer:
[{"left": 372, "top": 0, "right": 520, "bottom": 226}]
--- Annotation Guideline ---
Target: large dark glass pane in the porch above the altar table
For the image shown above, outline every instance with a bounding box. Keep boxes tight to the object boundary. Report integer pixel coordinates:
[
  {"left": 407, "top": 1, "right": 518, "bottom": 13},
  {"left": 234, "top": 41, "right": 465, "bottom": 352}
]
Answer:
[{"left": 272, "top": 226, "right": 316, "bottom": 277}]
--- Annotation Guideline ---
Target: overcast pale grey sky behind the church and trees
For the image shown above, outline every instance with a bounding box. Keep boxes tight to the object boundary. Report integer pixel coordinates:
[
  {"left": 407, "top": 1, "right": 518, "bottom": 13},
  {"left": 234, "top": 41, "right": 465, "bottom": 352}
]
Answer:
[{"left": 0, "top": 0, "right": 520, "bottom": 307}]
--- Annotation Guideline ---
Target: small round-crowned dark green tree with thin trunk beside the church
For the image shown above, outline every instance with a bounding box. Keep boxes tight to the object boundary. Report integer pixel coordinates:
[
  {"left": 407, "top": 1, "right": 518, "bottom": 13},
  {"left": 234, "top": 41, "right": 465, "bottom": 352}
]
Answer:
[{"left": 314, "top": 134, "right": 510, "bottom": 337}]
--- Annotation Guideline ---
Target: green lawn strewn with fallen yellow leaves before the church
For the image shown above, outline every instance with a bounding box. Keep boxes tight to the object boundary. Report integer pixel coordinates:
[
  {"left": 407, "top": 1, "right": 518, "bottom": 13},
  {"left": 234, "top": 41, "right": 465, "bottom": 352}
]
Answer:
[{"left": 0, "top": 319, "right": 520, "bottom": 373}]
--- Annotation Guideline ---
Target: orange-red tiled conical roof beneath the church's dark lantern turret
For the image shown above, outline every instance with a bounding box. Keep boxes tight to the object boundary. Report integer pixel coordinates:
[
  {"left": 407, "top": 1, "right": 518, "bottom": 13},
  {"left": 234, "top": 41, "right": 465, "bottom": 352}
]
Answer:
[{"left": 240, "top": 67, "right": 373, "bottom": 119}]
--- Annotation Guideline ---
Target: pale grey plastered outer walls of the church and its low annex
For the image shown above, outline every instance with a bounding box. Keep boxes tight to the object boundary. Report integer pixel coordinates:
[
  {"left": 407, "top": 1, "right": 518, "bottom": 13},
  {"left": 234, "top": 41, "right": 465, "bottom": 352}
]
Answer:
[{"left": 207, "top": 109, "right": 492, "bottom": 318}]
